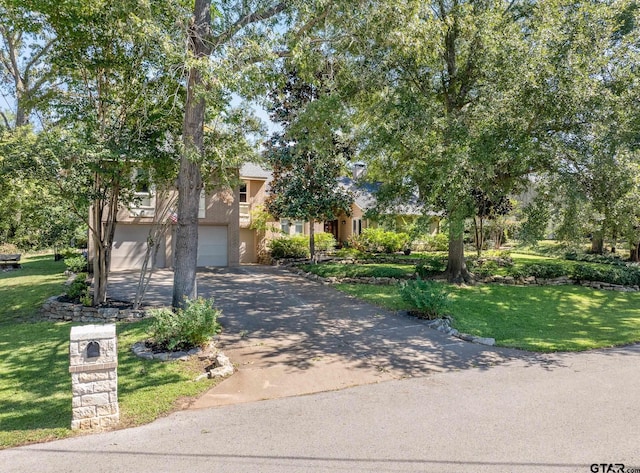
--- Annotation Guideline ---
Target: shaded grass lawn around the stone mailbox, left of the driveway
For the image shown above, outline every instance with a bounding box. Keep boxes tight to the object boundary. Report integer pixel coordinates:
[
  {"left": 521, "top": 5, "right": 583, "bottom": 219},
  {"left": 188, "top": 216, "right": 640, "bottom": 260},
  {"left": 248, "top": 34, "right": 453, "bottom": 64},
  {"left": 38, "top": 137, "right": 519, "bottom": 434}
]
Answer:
[{"left": 0, "top": 257, "right": 214, "bottom": 449}]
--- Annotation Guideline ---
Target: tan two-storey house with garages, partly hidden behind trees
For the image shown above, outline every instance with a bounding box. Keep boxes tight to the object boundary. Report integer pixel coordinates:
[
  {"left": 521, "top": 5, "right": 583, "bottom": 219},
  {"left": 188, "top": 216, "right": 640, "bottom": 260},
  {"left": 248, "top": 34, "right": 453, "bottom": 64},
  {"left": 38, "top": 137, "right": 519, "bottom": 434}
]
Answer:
[{"left": 104, "top": 163, "right": 437, "bottom": 270}]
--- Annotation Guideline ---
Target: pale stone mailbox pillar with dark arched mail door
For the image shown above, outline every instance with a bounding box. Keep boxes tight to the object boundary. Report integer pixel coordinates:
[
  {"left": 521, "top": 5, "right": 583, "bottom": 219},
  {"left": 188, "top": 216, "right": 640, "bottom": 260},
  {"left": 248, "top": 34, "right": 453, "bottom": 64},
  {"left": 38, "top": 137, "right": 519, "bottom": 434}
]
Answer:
[{"left": 69, "top": 324, "right": 120, "bottom": 430}]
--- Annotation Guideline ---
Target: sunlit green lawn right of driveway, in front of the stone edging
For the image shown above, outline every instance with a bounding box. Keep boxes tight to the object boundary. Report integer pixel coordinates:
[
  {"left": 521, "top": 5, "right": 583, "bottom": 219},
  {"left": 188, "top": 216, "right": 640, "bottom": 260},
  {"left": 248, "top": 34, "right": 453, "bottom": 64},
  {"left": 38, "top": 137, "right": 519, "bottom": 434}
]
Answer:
[{"left": 336, "top": 284, "right": 640, "bottom": 352}]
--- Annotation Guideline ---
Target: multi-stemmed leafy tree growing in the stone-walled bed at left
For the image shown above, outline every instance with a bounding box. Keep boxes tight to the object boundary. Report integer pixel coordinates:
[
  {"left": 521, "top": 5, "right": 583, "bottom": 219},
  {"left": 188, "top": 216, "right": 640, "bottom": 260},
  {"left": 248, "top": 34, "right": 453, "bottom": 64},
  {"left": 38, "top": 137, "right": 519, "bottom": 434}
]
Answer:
[{"left": 32, "top": 1, "right": 184, "bottom": 304}]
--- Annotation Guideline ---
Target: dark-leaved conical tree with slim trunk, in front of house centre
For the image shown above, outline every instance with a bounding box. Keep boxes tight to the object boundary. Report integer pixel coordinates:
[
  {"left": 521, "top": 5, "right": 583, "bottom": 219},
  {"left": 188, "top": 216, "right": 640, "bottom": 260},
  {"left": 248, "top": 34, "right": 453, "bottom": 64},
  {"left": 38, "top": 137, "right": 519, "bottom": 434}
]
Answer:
[{"left": 265, "top": 62, "right": 353, "bottom": 258}]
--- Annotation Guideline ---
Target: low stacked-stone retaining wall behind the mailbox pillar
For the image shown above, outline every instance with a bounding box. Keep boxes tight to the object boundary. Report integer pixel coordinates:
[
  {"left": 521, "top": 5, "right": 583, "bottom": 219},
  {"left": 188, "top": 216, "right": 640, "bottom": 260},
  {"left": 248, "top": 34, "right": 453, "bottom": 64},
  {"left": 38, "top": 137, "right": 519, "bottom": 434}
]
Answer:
[{"left": 41, "top": 296, "right": 148, "bottom": 323}]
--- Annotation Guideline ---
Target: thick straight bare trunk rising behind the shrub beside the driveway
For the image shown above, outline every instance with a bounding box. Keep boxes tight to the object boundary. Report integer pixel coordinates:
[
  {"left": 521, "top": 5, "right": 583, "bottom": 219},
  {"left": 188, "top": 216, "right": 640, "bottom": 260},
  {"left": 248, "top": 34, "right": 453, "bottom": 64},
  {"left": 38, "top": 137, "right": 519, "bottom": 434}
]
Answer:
[{"left": 172, "top": 0, "right": 211, "bottom": 308}]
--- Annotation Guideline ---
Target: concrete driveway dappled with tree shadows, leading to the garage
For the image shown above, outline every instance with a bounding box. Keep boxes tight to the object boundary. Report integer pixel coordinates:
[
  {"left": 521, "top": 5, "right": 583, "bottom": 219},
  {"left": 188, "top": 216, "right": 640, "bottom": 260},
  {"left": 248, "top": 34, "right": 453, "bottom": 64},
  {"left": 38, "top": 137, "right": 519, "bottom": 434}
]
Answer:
[{"left": 110, "top": 266, "right": 524, "bottom": 408}]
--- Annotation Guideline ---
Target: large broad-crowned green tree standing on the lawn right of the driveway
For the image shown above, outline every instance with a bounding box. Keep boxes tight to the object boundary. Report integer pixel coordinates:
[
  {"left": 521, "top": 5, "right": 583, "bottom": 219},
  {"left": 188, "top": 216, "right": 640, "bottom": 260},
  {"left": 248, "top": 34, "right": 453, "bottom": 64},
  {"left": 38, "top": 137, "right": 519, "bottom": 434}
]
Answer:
[{"left": 330, "top": 0, "right": 624, "bottom": 281}]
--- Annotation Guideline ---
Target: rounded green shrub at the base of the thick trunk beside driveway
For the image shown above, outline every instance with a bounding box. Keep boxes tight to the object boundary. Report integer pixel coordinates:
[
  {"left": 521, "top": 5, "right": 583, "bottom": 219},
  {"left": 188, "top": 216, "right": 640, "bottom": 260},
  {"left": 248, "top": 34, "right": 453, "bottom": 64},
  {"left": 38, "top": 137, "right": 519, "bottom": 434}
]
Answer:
[{"left": 148, "top": 297, "right": 220, "bottom": 351}]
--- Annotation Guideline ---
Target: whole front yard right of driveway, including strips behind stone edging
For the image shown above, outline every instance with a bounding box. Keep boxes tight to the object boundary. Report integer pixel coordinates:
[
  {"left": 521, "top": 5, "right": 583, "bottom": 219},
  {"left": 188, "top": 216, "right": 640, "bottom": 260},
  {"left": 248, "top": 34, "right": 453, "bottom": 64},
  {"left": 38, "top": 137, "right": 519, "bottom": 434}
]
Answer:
[{"left": 303, "top": 249, "right": 640, "bottom": 352}]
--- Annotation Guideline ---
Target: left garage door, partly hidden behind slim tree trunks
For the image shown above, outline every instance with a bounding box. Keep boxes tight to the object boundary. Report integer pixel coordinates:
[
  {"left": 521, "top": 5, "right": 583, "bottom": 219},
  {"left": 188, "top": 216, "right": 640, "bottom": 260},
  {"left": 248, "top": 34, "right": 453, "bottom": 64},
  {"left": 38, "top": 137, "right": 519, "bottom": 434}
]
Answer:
[{"left": 111, "top": 224, "right": 165, "bottom": 270}]
